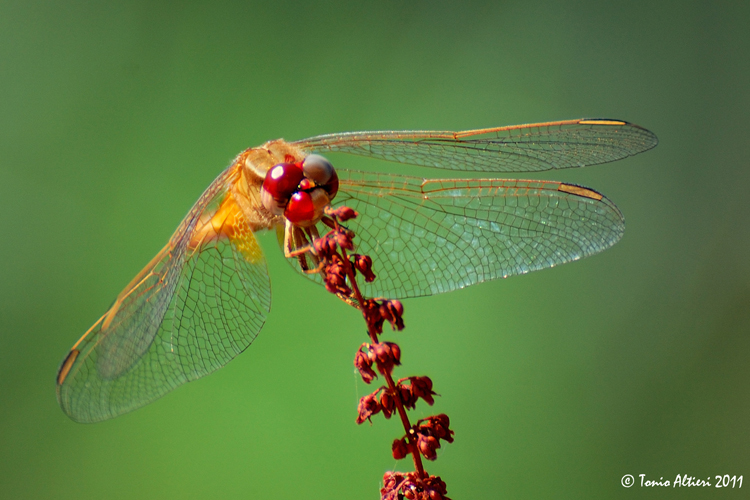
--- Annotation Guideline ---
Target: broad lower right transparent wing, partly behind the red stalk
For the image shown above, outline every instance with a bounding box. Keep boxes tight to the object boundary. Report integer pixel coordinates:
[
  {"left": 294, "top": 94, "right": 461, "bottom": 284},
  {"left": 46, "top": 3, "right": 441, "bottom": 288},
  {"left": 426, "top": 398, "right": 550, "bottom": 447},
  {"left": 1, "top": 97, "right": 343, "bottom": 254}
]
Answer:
[{"left": 290, "top": 171, "right": 625, "bottom": 298}]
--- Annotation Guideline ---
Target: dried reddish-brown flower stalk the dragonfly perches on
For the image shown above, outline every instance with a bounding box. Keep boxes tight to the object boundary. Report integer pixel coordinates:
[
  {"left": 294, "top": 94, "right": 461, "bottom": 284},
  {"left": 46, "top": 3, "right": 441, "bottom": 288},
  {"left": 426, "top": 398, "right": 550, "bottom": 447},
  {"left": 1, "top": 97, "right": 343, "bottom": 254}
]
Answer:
[{"left": 308, "top": 207, "right": 453, "bottom": 500}]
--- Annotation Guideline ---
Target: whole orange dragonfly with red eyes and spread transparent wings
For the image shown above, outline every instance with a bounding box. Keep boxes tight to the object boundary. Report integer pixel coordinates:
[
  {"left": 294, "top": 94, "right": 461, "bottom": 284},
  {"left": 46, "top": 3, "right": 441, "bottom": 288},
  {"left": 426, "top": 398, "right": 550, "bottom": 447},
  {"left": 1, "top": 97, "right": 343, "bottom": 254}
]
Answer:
[{"left": 56, "top": 118, "right": 658, "bottom": 422}]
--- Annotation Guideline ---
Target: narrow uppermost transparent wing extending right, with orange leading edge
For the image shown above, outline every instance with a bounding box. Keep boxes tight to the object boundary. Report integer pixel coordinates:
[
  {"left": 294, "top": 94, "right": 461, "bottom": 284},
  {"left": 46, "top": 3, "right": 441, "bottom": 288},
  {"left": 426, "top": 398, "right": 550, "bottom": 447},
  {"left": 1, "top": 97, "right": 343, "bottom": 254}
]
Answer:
[{"left": 293, "top": 119, "right": 658, "bottom": 172}]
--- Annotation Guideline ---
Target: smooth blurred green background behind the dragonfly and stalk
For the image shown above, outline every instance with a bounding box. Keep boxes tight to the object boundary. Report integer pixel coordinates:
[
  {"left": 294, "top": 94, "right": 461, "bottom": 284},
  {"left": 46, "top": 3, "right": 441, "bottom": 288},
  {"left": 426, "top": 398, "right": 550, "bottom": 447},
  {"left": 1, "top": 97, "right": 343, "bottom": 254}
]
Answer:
[{"left": 0, "top": 1, "right": 750, "bottom": 499}]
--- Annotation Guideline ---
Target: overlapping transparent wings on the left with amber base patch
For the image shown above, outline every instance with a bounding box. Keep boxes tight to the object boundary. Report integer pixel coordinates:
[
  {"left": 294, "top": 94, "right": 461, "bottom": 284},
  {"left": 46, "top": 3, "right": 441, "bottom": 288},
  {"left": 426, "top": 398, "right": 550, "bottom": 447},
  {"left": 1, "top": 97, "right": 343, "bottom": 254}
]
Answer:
[{"left": 57, "top": 167, "right": 271, "bottom": 422}]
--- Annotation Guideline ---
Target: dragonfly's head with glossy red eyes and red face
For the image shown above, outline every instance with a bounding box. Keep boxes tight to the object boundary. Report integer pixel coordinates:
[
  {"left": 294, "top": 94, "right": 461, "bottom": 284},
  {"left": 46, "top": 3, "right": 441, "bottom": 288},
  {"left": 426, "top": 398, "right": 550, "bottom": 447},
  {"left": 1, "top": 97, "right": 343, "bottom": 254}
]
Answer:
[{"left": 260, "top": 154, "right": 339, "bottom": 227}]
